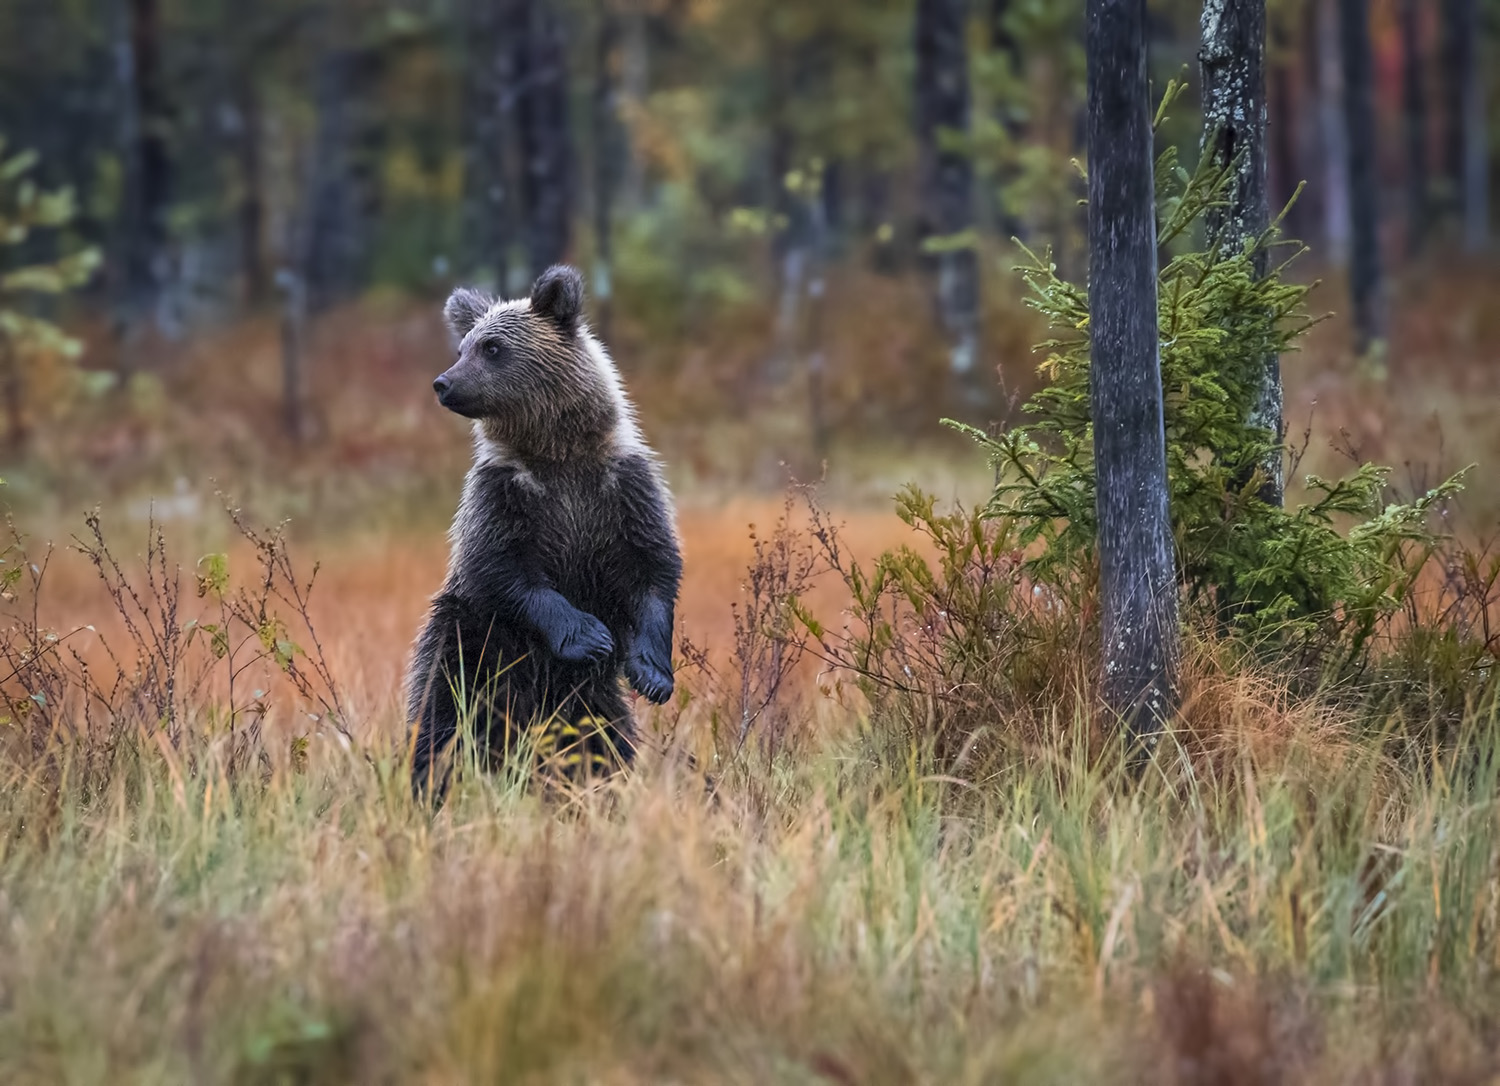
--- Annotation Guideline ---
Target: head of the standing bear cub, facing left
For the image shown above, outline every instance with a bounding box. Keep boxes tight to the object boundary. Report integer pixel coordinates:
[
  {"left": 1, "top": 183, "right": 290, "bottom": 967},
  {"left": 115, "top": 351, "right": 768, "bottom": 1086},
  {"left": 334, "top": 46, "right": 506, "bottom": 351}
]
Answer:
[{"left": 432, "top": 266, "right": 627, "bottom": 456}]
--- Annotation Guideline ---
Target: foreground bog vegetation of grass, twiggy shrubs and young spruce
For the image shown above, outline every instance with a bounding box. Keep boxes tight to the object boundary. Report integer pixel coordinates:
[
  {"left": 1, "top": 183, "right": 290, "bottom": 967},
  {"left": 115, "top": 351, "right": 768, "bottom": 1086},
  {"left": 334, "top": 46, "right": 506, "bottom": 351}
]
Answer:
[{"left": 0, "top": 131, "right": 1500, "bottom": 1083}]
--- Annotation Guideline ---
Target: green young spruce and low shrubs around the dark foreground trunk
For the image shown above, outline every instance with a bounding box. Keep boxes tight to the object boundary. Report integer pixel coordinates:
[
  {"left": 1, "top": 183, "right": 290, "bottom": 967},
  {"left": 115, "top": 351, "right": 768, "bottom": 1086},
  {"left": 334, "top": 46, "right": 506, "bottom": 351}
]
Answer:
[{"left": 801, "top": 87, "right": 1488, "bottom": 753}]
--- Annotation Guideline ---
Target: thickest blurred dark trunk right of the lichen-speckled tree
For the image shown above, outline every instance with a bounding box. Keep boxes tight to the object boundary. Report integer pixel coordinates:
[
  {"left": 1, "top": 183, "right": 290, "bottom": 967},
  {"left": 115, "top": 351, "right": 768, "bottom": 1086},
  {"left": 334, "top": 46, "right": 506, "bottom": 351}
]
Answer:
[{"left": 1338, "top": 0, "right": 1383, "bottom": 356}]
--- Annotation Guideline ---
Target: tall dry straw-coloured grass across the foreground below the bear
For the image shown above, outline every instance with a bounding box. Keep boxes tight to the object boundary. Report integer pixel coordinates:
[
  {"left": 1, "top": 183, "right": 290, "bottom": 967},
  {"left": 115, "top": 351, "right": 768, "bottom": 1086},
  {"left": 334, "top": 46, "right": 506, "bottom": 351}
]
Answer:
[{"left": 0, "top": 504, "right": 1500, "bottom": 1083}]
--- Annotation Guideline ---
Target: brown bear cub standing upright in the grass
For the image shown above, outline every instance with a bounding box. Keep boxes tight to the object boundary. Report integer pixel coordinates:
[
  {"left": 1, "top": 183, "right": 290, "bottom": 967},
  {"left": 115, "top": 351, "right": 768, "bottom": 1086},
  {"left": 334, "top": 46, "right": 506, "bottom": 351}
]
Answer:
[{"left": 407, "top": 267, "right": 683, "bottom": 795}]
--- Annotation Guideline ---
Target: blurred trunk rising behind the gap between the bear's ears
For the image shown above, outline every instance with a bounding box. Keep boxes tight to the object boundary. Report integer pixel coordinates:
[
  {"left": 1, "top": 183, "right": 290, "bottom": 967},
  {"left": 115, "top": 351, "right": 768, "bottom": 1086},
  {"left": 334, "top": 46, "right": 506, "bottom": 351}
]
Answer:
[{"left": 461, "top": 0, "right": 516, "bottom": 293}]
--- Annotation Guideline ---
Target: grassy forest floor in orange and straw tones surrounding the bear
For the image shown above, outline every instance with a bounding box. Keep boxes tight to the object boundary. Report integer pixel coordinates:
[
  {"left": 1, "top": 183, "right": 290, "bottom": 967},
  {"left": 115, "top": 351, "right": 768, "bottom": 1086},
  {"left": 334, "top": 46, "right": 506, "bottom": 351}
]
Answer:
[{"left": 0, "top": 261, "right": 1500, "bottom": 1083}]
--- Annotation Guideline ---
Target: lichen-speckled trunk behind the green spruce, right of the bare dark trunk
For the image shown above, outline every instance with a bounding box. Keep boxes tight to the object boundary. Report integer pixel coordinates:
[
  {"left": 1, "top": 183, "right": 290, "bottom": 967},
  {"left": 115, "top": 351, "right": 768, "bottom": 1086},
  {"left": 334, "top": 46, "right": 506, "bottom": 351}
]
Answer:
[{"left": 1199, "top": 0, "right": 1284, "bottom": 506}]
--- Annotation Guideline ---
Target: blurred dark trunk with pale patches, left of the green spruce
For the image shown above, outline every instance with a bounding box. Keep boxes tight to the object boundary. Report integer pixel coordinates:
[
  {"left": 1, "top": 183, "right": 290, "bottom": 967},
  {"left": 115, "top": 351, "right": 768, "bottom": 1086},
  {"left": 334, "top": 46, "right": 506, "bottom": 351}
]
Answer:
[{"left": 914, "top": 0, "right": 980, "bottom": 398}]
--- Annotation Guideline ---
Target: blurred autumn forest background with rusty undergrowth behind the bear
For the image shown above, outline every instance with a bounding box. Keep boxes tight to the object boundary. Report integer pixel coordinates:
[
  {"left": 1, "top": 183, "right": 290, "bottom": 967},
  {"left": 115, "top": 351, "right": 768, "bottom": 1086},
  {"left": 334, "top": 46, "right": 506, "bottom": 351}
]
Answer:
[{"left": 0, "top": 0, "right": 1500, "bottom": 524}]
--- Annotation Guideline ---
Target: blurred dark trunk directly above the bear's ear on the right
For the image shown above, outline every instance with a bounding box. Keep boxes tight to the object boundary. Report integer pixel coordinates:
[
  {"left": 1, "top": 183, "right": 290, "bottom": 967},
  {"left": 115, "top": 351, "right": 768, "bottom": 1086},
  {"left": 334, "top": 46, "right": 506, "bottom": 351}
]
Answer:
[{"left": 515, "top": 0, "right": 576, "bottom": 276}]
